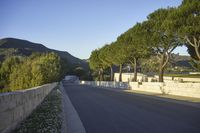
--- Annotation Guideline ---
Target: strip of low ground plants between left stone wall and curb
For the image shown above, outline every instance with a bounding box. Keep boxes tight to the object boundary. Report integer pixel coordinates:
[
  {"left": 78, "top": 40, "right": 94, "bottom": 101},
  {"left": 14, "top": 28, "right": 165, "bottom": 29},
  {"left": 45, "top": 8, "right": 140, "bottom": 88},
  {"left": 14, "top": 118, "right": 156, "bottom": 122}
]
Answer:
[{"left": 13, "top": 87, "right": 62, "bottom": 133}]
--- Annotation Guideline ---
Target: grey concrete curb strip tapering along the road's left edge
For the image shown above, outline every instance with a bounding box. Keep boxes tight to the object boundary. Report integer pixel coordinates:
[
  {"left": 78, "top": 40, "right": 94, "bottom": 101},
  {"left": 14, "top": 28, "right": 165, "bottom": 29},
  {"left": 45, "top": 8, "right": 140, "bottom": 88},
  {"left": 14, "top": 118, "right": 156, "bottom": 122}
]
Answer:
[{"left": 60, "top": 83, "right": 86, "bottom": 133}]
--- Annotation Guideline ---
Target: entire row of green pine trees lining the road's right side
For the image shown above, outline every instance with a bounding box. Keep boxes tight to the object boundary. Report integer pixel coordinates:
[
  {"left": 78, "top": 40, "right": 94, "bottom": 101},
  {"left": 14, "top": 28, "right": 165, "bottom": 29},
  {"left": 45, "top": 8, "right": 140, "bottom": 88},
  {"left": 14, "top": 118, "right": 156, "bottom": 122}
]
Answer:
[{"left": 89, "top": 0, "right": 200, "bottom": 82}]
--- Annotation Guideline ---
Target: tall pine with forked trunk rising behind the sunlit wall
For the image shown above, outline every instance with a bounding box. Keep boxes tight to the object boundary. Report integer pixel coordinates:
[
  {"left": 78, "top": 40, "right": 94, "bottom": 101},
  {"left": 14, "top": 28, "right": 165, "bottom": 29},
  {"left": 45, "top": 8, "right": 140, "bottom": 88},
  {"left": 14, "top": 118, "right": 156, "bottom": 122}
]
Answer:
[{"left": 146, "top": 8, "right": 181, "bottom": 82}]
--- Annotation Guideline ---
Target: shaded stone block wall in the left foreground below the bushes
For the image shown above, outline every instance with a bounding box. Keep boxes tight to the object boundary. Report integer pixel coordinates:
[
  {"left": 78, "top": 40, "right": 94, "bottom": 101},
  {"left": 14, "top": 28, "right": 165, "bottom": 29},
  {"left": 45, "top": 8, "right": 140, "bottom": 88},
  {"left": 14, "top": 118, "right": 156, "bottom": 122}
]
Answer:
[{"left": 0, "top": 83, "right": 57, "bottom": 133}]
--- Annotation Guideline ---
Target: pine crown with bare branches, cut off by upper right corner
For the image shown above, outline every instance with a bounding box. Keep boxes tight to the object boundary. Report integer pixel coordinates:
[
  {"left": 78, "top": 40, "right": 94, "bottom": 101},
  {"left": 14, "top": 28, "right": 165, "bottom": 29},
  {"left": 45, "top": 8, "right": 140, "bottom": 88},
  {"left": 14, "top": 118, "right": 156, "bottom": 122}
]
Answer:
[{"left": 168, "top": 0, "right": 200, "bottom": 60}]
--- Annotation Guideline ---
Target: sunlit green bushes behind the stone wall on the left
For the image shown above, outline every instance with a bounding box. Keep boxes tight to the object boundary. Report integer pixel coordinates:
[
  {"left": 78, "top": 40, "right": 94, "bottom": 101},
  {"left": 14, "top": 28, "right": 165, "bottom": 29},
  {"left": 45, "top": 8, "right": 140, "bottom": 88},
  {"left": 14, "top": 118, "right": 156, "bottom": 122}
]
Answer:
[{"left": 0, "top": 53, "right": 63, "bottom": 92}]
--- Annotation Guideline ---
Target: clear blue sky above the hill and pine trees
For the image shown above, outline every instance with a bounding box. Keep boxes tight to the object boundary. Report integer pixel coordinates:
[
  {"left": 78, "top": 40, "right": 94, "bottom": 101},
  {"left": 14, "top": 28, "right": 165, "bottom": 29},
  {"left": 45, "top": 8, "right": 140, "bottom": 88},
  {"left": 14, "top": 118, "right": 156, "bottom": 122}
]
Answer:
[{"left": 0, "top": 0, "right": 187, "bottom": 59}]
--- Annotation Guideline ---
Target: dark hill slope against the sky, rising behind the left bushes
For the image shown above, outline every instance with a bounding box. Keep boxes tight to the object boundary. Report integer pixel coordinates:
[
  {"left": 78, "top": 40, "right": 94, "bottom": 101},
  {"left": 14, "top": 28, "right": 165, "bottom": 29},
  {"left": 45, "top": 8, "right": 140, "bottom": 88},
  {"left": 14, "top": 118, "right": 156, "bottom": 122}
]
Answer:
[{"left": 0, "top": 38, "right": 89, "bottom": 69}]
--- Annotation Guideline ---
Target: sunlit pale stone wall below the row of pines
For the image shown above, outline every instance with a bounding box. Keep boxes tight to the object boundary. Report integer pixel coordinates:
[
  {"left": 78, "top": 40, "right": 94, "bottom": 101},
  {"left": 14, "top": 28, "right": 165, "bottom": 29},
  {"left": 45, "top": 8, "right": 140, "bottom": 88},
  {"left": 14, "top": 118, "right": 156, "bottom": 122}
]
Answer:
[{"left": 81, "top": 81, "right": 200, "bottom": 98}]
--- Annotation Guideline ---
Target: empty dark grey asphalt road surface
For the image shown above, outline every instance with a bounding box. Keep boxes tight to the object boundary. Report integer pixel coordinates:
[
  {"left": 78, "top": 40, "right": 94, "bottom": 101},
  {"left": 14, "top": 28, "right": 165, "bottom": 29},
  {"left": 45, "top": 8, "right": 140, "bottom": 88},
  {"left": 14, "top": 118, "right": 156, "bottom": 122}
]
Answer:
[{"left": 64, "top": 84, "right": 200, "bottom": 133}]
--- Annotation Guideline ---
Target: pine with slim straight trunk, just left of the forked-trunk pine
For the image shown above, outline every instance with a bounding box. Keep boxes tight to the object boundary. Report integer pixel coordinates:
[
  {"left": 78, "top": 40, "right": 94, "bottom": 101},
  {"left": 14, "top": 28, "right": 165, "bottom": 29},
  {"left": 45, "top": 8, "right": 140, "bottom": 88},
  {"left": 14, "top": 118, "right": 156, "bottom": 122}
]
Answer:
[{"left": 117, "top": 23, "right": 152, "bottom": 81}]
